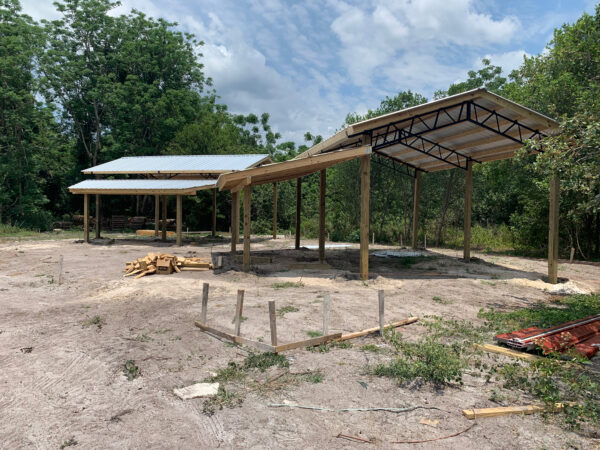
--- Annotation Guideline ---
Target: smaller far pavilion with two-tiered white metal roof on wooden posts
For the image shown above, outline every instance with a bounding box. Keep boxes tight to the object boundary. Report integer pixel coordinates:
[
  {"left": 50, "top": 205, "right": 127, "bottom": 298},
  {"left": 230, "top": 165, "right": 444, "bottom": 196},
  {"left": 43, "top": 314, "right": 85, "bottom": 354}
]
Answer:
[{"left": 69, "top": 154, "right": 271, "bottom": 245}]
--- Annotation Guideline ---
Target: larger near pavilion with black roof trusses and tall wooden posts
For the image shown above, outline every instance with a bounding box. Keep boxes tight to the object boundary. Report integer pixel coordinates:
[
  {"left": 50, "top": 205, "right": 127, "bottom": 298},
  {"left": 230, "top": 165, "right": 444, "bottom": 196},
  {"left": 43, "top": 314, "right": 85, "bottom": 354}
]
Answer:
[{"left": 217, "top": 88, "right": 559, "bottom": 283}]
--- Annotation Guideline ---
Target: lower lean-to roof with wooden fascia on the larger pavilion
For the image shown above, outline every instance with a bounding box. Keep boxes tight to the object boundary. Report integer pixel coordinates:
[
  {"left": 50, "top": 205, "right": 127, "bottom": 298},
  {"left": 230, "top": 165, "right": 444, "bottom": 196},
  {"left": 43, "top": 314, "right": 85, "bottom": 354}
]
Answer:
[{"left": 217, "top": 145, "right": 371, "bottom": 192}]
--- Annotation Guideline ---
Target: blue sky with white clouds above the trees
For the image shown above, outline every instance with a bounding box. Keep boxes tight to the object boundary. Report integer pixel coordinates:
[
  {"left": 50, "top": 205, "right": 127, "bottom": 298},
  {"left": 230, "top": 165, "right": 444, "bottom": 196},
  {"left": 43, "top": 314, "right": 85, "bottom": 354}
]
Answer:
[{"left": 22, "top": 0, "right": 596, "bottom": 143}]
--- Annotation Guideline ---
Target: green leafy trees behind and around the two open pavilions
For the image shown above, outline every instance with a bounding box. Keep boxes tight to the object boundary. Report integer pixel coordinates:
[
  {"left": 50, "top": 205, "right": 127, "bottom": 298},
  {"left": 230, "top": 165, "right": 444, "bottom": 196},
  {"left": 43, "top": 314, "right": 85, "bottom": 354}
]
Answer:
[{"left": 0, "top": 0, "right": 600, "bottom": 259}]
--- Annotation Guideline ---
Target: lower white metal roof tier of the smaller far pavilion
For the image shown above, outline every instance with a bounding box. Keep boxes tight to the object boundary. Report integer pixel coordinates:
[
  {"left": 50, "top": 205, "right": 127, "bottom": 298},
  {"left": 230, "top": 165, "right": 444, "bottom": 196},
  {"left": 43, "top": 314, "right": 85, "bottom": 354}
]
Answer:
[{"left": 69, "top": 180, "right": 216, "bottom": 195}]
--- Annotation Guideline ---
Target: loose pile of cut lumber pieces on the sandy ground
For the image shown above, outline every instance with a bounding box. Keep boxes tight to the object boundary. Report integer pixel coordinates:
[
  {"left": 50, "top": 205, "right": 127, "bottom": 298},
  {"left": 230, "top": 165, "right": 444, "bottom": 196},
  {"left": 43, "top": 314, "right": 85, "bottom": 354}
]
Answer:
[{"left": 124, "top": 253, "right": 214, "bottom": 278}]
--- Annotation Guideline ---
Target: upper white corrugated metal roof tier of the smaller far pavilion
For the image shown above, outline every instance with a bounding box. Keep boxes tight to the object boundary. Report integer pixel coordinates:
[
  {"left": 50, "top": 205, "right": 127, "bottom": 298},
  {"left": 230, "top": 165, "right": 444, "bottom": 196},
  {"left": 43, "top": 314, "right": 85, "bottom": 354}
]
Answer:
[{"left": 82, "top": 154, "right": 271, "bottom": 174}]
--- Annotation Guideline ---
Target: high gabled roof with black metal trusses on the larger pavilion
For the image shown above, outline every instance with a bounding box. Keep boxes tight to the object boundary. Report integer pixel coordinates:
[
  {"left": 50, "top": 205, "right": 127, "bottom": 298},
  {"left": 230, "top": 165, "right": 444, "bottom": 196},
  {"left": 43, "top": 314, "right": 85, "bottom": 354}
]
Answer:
[{"left": 295, "top": 88, "right": 558, "bottom": 172}]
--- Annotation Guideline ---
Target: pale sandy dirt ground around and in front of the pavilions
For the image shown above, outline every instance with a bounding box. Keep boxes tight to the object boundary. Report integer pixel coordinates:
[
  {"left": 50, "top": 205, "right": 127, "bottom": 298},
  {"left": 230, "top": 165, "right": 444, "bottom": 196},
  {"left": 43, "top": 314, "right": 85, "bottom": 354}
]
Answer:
[{"left": 0, "top": 237, "right": 600, "bottom": 449}]
